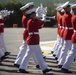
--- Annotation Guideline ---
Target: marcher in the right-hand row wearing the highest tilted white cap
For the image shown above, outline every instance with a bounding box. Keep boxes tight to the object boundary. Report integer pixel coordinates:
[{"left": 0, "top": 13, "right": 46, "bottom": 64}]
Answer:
[{"left": 58, "top": 1, "right": 73, "bottom": 68}]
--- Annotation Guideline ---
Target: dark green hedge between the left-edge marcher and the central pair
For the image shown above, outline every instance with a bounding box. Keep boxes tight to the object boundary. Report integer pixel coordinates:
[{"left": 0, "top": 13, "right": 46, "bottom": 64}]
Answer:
[{"left": 0, "top": 0, "right": 23, "bottom": 27}]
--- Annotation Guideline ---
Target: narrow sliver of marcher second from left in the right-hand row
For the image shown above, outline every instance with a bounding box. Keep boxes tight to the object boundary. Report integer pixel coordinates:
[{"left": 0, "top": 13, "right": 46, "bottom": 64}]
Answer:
[{"left": 55, "top": 8, "right": 65, "bottom": 59}]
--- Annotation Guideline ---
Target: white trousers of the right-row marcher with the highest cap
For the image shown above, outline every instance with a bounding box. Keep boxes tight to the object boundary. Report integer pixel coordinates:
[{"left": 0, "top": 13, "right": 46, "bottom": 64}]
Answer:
[{"left": 58, "top": 40, "right": 72, "bottom": 65}]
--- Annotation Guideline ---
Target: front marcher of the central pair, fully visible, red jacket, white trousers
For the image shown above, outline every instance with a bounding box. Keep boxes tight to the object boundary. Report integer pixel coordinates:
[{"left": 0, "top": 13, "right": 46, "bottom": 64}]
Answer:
[{"left": 19, "top": 8, "right": 51, "bottom": 74}]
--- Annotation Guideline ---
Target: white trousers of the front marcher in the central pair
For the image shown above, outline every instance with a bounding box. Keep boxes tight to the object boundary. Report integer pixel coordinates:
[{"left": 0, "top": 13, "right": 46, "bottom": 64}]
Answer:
[{"left": 19, "top": 45, "right": 48, "bottom": 70}]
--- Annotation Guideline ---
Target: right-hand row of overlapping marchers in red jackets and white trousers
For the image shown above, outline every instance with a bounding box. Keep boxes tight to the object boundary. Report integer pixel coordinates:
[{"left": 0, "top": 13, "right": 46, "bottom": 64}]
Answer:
[{"left": 52, "top": 1, "right": 76, "bottom": 73}]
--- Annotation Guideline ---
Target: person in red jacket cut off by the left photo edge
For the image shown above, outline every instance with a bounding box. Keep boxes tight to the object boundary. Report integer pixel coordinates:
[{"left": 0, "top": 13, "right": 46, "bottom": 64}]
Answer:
[{"left": 0, "top": 10, "right": 10, "bottom": 60}]
